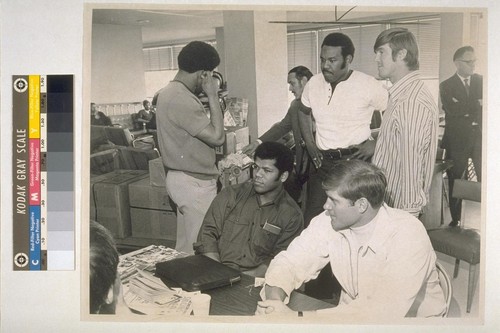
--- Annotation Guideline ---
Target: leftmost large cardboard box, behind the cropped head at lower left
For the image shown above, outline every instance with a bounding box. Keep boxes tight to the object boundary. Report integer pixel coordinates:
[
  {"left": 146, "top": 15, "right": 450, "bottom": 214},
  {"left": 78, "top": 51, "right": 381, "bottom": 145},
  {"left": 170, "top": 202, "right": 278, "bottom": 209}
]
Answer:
[{"left": 90, "top": 170, "right": 148, "bottom": 238}]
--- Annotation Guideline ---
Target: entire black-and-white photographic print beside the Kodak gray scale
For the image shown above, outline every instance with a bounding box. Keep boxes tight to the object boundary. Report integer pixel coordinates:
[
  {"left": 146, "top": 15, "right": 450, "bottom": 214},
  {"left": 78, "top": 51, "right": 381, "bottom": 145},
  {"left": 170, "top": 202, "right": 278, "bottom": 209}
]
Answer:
[{"left": 87, "top": 5, "right": 488, "bottom": 323}]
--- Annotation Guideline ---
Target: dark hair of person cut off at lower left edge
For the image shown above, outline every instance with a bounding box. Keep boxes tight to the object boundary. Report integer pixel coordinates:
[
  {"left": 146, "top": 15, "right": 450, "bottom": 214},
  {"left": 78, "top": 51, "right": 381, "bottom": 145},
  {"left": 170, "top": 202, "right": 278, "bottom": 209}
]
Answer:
[{"left": 89, "top": 221, "right": 118, "bottom": 313}]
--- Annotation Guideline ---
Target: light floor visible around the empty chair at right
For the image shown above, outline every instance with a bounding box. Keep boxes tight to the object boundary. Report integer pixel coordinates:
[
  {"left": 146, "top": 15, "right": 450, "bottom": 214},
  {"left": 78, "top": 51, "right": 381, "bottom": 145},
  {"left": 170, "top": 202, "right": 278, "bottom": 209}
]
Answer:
[{"left": 436, "top": 189, "right": 484, "bottom": 318}]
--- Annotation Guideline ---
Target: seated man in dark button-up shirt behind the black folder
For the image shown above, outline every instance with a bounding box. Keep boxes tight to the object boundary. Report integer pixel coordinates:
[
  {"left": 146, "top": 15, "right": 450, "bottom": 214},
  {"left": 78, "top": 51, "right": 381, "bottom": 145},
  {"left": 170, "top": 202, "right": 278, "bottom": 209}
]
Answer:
[{"left": 194, "top": 142, "right": 304, "bottom": 277}]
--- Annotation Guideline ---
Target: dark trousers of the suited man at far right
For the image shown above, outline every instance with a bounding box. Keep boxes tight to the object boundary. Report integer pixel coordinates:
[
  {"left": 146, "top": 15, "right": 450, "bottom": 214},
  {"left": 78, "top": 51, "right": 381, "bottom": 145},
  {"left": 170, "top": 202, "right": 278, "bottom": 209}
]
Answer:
[{"left": 446, "top": 129, "right": 481, "bottom": 221}]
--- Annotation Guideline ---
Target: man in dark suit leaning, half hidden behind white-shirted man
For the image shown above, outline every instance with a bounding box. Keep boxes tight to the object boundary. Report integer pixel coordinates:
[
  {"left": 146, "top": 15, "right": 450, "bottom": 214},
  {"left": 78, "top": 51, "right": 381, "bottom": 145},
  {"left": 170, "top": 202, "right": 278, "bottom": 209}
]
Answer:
[{"left": 242, "top": 66, "right": 313, "bottom": 202}]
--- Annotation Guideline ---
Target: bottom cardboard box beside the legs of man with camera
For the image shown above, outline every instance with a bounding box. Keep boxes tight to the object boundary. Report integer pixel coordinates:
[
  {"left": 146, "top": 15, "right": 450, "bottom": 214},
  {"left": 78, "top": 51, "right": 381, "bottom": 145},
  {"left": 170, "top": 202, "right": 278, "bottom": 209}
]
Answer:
[{"left": 130, "top": 208, "right": 177, "bottom": 241}]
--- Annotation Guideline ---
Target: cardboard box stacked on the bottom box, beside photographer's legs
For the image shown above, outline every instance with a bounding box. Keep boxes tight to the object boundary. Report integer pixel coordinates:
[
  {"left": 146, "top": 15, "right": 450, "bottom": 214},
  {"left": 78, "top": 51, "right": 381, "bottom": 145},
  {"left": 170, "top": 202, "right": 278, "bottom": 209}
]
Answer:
[{"left": 128, "top": 177, "right": 175, "bottom": 211}]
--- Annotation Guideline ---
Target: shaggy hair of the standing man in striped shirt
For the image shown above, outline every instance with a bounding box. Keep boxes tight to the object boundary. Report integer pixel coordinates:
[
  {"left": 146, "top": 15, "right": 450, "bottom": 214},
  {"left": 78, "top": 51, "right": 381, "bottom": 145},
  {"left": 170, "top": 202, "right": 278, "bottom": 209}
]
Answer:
[{"left": 373, "top": 28, "right": 420, "bottom": 70}]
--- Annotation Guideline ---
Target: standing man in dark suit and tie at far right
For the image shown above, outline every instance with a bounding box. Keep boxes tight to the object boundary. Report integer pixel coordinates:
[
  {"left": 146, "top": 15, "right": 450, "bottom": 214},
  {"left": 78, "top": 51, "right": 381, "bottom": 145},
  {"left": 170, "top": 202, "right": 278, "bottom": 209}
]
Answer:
[{"left": 439, "top": 46, "right": 483, "bottom": 226}]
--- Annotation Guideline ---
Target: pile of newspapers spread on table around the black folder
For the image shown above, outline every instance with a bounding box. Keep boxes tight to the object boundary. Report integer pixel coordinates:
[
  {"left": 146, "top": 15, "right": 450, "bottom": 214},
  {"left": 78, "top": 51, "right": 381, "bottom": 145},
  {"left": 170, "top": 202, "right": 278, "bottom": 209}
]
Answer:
[{"left": 118, "top": 245, "right": 199, "bottom": 315}]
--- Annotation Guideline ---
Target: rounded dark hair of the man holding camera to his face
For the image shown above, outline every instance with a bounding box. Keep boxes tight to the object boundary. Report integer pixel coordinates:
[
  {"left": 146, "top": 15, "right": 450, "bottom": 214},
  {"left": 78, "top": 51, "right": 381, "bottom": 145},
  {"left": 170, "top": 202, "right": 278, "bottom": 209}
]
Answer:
[{"left": 177, "top": 41, "right": 220, "bottom": 73}]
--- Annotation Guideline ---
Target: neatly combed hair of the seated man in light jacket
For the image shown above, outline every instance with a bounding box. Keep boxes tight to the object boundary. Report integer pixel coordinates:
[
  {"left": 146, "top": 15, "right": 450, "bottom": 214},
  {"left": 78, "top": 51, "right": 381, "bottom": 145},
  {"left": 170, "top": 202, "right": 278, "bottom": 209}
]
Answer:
[{"left": 322, "top": 159, "right": 387, "bottom": 208}]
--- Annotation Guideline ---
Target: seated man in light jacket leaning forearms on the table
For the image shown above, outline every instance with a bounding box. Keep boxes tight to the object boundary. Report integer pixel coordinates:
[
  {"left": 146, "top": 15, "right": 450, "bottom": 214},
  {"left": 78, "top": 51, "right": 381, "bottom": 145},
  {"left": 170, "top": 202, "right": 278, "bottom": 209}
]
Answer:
[{"left": 256, "top": 160, "right": 446, "bottom": 320}]
